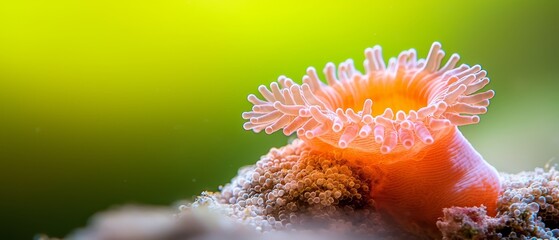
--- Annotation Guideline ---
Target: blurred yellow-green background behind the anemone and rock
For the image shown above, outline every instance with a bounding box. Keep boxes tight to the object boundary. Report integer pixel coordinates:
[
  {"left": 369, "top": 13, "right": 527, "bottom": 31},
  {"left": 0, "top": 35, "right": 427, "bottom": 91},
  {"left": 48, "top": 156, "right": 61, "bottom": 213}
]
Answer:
[{"left": 0, "top": 0, "right": 559, "bottom": 239}]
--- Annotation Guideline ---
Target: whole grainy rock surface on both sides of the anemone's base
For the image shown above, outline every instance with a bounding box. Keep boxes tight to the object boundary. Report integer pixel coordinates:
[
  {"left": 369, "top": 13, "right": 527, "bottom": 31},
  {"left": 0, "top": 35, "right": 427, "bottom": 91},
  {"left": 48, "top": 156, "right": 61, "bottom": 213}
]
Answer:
[{"left": 39, "top": 145, "right": 559, "bottom": 240}]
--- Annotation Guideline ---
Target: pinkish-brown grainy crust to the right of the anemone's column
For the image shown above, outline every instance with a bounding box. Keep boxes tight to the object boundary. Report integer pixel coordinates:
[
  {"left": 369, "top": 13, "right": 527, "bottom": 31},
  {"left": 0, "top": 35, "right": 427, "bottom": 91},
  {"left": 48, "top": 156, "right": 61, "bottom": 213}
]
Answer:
[{"left": 437, "top": 168, "right": 559, "bottom": 239}]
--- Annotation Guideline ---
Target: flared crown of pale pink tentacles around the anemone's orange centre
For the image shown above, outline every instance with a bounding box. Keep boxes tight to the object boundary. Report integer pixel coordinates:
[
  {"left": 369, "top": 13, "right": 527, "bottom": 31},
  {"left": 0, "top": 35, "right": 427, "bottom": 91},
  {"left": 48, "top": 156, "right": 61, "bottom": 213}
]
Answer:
[{"left": 243, "top": 42, "right": 494, "bottom": 153}]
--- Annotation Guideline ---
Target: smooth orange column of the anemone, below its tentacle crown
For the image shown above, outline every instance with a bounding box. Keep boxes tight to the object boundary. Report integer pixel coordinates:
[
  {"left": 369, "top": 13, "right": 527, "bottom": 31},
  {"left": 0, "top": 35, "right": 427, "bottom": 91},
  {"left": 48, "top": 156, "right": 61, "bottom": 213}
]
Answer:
[{"left": 371, "top": 127, "right": 500, "bottom": 238}]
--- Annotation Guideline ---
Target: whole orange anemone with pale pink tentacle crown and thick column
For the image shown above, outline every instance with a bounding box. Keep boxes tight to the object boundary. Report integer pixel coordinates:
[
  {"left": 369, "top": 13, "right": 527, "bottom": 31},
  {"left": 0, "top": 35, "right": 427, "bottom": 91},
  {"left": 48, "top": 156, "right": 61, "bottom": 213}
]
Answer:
[{"left": 243, "top": 42, "right": 500, "bottom": 237}]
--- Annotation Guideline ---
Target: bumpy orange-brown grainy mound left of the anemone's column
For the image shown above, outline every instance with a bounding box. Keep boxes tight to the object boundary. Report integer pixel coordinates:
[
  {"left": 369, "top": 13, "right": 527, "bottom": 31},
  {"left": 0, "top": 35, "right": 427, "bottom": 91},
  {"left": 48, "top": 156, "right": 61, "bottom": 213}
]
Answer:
[{"left": 217, "top": 140, "right": 378, "bottom": 231}]
